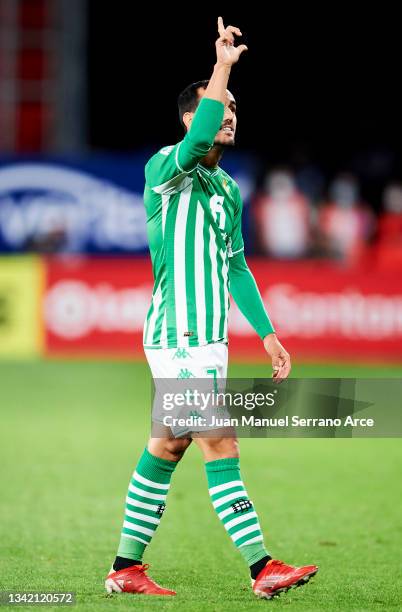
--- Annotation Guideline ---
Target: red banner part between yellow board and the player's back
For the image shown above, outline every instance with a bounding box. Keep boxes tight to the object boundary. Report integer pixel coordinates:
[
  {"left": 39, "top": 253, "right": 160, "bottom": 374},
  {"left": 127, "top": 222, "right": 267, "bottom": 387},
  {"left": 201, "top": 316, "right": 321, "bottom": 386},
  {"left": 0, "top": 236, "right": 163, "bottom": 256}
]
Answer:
[{"left": 43, "top": 258, "right": 152, "bottom": 356}]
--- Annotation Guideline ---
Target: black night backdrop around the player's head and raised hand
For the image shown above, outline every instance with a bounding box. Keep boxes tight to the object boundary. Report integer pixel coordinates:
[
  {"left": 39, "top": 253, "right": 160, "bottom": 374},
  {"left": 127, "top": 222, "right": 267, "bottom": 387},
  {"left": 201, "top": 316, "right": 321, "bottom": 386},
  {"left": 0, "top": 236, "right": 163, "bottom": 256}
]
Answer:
[{"left": 89, "top": 0, "right": 401, "bottom": 202}]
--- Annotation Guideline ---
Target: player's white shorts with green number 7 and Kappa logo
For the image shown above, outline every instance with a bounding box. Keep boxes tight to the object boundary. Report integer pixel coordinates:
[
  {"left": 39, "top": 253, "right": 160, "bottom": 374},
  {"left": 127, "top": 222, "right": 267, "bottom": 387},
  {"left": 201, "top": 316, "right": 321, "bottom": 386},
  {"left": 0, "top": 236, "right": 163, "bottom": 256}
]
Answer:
[{"left": 144, "top": 342, "right": 229, "bottom": 437}]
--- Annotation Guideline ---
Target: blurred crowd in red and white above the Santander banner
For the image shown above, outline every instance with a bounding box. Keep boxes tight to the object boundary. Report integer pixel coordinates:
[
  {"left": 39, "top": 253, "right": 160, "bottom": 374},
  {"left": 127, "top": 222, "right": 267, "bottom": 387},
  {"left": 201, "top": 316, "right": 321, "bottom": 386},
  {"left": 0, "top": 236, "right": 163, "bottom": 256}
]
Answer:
[{"left": 251, "top": 168, "right": 402, "bottom": 267}]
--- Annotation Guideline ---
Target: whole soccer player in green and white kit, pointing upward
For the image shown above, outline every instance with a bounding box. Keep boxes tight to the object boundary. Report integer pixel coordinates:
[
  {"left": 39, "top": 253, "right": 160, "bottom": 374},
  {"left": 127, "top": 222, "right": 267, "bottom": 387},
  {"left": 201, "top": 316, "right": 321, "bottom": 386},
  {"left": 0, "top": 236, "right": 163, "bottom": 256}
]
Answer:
[{"left": 105, "top": 17, "right": 318, "bottom": 599}]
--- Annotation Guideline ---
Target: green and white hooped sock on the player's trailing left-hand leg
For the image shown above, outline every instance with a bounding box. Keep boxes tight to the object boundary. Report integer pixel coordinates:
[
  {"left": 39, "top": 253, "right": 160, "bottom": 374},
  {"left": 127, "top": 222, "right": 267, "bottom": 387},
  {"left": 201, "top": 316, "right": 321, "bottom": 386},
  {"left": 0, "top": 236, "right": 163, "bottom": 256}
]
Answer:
[{"left": 117, "top": 448, "right": 177, "bottom": 561}]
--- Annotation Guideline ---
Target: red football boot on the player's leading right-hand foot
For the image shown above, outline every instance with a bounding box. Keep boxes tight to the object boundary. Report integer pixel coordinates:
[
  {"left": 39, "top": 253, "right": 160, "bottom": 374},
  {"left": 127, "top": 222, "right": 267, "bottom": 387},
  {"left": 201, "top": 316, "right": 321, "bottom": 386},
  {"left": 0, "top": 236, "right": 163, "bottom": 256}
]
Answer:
[{"left": 251, "top": 559, "right": 318, "bottom": 599}]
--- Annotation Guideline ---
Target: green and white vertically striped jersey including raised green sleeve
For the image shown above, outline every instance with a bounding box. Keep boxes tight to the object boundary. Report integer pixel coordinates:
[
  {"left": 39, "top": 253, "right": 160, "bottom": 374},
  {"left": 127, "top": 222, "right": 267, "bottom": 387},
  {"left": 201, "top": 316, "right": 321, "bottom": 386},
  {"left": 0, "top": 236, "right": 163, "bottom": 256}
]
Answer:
[{"left": 144, "top": 98, "right": 244, "bottom": 348}]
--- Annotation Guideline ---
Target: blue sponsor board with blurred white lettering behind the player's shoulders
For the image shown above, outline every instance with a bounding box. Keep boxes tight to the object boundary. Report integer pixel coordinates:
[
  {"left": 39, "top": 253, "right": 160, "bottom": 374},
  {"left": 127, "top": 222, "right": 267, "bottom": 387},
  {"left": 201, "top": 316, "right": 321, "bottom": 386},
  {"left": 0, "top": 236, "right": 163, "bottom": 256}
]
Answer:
[{"left": 0, "top": 151, "right": 254, "bottom": 254}]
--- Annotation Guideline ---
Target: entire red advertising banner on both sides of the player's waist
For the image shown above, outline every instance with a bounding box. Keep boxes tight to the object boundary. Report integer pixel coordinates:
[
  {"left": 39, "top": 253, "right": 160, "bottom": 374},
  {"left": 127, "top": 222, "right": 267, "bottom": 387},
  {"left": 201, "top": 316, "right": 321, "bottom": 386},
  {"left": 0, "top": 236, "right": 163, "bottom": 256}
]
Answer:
[{"left": 43, "top": 258, "right": 402, "bottom": 361}]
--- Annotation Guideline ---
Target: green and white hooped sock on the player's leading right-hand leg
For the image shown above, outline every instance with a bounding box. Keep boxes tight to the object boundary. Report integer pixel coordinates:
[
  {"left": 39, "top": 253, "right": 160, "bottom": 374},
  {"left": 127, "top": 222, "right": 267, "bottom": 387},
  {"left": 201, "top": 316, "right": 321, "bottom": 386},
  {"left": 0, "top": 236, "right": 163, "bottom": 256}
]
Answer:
[{"left": 205, "top": 458, "right": 269, "bottom": 566}]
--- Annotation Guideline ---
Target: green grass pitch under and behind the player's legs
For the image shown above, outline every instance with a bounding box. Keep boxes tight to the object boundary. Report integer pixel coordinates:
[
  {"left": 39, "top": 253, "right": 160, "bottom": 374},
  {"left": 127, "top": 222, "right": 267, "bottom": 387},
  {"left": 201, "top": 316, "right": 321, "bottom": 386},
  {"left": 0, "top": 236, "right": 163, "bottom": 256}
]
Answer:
[{"left": 0, "top": 361, "right": 402, "bottom": 612}]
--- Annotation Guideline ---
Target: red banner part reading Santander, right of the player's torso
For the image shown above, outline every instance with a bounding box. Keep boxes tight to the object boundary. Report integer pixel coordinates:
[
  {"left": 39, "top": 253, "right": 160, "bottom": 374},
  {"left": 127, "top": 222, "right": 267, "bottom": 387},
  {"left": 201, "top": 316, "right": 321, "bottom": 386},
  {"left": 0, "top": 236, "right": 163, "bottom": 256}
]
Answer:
[{"left": 232, "top": 260, "right": 402, "bottom": 361}]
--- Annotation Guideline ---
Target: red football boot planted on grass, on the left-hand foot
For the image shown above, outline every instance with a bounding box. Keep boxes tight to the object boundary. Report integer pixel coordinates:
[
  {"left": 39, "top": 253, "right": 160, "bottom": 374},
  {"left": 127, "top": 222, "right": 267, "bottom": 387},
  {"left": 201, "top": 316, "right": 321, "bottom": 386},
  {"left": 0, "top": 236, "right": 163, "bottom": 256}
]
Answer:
[{"left": 105, "top": 564, "right": 176, "bottom": 595}]
